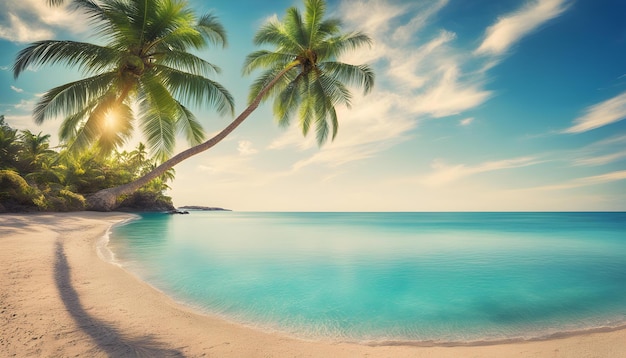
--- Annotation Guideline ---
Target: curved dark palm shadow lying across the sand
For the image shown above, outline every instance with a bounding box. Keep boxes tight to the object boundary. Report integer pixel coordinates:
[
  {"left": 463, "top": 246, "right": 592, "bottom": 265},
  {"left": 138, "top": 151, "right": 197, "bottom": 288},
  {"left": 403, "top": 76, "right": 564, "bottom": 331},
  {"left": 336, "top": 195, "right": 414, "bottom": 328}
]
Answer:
[{"left": 54, "top": 241, "right": 184, "bottom": 357}]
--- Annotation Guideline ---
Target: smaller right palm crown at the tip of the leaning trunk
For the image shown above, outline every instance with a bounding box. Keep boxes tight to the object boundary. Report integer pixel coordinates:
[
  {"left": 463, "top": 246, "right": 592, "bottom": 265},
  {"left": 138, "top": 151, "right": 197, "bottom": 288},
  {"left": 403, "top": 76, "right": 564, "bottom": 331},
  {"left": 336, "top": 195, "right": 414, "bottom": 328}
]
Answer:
[{"left": 243, "top": 0, "right": 374, "bottom": 145}]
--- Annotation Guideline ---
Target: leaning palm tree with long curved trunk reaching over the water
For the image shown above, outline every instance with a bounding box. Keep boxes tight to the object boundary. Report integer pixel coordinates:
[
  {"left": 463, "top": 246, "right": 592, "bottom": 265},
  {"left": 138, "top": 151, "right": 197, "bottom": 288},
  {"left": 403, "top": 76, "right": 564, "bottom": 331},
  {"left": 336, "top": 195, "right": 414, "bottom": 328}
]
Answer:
[{"left": 28, "top": 0, "right": 374, "bottom": 211}]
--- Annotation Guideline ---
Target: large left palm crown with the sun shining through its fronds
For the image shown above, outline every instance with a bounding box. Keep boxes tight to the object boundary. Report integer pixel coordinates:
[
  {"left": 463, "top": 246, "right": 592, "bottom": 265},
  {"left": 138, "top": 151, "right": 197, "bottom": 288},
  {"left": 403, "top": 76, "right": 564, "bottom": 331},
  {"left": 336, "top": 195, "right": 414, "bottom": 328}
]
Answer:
[{"left": 13, "top": 0, "right": 234, "bottom": 160}]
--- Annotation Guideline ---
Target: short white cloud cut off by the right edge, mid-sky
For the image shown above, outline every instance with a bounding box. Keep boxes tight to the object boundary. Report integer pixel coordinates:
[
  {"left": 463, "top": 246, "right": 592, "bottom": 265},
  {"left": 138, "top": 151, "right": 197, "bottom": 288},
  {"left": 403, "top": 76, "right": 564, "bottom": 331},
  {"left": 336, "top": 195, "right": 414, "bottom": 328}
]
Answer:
[{"left": 563, "top": 92, "right": 626, "bottom": 133}]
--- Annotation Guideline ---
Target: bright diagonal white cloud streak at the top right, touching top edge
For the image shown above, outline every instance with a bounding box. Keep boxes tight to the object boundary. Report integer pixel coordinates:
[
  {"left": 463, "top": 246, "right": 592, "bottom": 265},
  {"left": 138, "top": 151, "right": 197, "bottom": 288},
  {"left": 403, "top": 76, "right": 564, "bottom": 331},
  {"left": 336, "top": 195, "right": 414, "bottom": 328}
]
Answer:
[{"left": 475, "top": 0, "right": 568, "bottom": 55}]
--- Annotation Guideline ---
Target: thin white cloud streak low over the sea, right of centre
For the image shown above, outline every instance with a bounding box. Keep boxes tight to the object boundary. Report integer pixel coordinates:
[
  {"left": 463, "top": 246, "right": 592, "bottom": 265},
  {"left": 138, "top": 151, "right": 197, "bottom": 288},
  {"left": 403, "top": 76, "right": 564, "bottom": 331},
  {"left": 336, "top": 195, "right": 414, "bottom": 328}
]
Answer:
[{"left": 418, "top": 157, "right": 539, "bottom": 187}]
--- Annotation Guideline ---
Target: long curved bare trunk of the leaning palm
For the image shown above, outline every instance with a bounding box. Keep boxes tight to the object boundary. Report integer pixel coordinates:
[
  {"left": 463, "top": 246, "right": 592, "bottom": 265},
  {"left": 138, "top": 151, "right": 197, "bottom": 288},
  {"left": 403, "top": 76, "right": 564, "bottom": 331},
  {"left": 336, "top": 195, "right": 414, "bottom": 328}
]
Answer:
[{"left": 87, "top": 63, "right": 297, "bottom": 211}]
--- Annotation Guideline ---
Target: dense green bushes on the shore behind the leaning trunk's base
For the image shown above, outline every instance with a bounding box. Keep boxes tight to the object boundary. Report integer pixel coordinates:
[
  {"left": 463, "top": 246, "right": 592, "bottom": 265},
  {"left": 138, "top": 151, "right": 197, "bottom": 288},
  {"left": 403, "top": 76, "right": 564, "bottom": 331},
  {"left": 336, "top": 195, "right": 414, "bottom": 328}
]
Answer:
[{"left": 0, "top": 116, "right": 174, "bottom": 212}]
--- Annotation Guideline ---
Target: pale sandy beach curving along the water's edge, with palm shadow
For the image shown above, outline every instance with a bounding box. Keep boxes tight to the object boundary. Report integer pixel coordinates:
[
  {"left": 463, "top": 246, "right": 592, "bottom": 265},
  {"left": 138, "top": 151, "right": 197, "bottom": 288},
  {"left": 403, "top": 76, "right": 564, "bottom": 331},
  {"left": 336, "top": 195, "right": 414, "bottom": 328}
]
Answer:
[{"left": 0, "top": 212, "right": 626, "bottom": 358}]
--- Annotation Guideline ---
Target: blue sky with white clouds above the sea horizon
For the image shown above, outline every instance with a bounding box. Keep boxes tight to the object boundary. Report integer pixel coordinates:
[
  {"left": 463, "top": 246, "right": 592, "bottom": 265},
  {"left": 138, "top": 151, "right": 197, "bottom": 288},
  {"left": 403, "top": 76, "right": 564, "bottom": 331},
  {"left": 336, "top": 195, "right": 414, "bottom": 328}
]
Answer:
[{"left": 0, "top": 0, "right": 626, "bottom": 211}]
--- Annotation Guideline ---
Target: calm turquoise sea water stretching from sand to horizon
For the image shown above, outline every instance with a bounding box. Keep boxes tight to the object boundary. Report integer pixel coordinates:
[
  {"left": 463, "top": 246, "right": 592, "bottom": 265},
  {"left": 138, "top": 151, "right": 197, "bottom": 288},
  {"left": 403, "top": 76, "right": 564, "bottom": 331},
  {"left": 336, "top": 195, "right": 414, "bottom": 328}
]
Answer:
[{"left": 108, "top": 211, "right": 626, "bottom": 343}]
